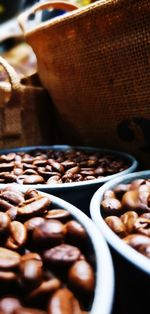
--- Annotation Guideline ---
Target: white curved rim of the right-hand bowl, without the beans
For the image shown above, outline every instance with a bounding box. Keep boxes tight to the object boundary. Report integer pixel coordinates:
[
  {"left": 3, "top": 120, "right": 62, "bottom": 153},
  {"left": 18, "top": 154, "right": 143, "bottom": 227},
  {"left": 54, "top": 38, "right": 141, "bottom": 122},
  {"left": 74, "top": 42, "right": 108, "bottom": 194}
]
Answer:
[{"left": 90, "top": 170, "right": 150, "bottom": 275}]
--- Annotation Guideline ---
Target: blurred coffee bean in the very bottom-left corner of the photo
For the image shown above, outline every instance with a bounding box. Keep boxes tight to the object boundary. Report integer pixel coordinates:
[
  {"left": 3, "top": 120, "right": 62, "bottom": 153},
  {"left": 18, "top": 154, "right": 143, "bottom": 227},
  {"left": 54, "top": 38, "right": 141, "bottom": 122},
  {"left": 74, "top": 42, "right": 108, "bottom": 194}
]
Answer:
[{"left": 0, "top": 297, "right": 21, "bottom": 314}]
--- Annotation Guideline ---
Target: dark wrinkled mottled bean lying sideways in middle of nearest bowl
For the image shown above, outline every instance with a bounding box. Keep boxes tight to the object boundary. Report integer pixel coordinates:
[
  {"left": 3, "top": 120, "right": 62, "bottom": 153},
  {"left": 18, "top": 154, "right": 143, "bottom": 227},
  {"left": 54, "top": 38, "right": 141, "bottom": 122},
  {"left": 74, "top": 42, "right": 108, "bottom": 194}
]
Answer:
[{"left": 43, "top": 244, "right": 81, "bottom": 266}]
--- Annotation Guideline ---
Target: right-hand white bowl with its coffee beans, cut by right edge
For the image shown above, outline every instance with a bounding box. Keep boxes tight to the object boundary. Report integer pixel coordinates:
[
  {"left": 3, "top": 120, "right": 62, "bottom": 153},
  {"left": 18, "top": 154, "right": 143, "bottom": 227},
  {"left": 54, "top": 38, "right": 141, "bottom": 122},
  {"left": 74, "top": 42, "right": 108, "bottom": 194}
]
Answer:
[{"left": 90, "top": 171, "right": 150, "bottom": 274}]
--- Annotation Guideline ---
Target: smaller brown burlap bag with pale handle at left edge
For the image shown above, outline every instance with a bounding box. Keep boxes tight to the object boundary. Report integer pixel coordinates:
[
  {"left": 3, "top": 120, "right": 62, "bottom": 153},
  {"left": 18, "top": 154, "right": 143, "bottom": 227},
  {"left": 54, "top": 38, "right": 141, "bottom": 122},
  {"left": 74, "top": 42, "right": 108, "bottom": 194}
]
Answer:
[{"left": 0, "top": 57, "right": 54, "bottom": 148}]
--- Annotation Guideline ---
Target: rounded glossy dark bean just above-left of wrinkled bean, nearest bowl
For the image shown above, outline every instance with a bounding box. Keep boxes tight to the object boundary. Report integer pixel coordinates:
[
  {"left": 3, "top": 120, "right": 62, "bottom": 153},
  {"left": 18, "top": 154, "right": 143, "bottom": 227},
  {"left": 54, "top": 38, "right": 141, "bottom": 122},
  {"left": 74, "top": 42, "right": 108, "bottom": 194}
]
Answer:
[{"left": 32, "top": 219, "right": 65, "bottom": 246}]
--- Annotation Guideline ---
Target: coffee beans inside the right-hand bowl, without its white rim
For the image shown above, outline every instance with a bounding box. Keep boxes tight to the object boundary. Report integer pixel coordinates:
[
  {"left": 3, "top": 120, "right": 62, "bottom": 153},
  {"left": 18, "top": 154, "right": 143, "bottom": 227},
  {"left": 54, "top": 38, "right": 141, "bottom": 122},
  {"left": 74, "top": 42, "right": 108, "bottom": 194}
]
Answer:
[{"left": 101, "top": 178, "right": 150, "bottom": 258}]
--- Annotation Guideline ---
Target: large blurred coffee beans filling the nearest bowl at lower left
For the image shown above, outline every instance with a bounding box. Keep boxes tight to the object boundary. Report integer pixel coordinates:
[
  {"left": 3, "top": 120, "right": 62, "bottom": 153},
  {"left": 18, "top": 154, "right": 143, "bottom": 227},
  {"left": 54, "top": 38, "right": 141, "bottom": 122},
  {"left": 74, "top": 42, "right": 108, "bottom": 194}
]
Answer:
[{"left": 0, "top": 185, "right": 96, "bottom": 314}]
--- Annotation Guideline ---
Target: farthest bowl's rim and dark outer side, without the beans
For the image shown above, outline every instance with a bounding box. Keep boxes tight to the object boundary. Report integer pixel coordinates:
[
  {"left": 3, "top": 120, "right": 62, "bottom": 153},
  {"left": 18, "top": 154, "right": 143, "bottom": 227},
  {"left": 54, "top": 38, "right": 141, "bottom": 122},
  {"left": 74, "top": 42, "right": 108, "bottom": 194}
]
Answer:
[{"left": 0, "top": 145, "right": 138, "bottom": 213}]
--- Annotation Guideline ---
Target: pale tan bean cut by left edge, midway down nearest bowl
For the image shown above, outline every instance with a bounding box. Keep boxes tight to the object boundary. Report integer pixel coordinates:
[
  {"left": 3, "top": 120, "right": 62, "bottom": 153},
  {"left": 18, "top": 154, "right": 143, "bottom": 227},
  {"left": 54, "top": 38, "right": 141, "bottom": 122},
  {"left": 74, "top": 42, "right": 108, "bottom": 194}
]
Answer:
[{"left": 0, "top": 247, "right": 21, "bottom": 270}]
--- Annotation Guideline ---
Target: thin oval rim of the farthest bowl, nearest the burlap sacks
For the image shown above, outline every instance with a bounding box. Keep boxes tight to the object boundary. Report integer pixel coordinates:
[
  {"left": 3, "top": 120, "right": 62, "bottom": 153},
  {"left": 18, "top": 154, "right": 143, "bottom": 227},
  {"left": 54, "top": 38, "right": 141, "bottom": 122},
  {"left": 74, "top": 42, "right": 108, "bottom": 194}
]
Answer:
[{"left": 0, "top": 145, "right": 138, "bottom": 191}]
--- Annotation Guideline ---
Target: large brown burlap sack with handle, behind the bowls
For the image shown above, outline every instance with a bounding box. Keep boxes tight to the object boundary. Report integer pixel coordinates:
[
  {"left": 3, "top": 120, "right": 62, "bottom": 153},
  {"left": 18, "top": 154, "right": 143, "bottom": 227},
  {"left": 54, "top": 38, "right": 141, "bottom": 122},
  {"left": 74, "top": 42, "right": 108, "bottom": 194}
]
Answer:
[{"left": 19, "top": 0, "right": 150, "bottom": 168}]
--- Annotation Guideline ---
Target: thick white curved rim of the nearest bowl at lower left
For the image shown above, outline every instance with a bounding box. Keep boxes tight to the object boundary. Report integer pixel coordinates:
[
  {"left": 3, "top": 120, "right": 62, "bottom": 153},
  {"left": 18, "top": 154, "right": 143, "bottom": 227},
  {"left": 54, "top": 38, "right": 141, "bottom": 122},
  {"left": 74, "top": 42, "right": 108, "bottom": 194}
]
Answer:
[{"left": 0, "top": 184, "right": 115, "bottom": 314}]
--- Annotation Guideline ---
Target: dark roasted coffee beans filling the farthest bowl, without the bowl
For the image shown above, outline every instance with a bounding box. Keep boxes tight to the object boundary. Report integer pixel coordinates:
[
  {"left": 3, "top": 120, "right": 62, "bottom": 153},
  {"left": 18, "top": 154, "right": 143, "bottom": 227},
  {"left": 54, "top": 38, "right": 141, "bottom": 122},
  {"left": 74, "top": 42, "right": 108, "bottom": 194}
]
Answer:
[{"left": 0, "top": 149, "right": 130, "bottom": 184}]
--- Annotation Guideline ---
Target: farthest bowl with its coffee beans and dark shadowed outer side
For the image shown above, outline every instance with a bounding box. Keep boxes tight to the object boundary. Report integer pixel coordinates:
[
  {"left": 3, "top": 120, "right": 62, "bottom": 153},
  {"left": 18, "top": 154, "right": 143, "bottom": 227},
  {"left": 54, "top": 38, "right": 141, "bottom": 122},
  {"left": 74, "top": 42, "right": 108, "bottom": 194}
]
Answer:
[{"left": 0, "top": 145, "right": 137, "bottom": 213}]
